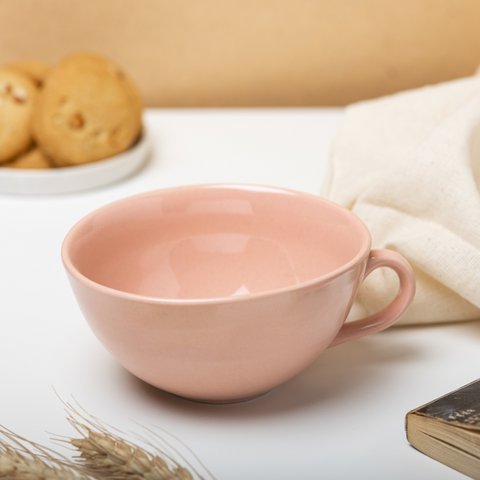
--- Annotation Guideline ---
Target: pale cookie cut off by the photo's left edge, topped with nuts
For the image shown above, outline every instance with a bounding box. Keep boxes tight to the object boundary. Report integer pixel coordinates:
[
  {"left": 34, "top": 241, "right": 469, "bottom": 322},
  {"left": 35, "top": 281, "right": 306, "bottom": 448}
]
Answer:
[{"left": 0, "top": 68, "right": 38, "bottom": 164}]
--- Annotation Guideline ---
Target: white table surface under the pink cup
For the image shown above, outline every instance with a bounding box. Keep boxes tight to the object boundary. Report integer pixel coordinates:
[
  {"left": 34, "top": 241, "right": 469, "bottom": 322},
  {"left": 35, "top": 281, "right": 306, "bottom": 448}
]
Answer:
[{"left": 0, "top": 109, "right": 480, "bottom": 480}]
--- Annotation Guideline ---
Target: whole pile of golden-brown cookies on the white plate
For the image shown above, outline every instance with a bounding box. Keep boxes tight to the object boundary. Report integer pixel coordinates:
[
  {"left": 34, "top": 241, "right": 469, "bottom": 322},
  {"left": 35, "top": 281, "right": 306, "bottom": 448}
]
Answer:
[{"left": 0, "top": 53, "right": 142, "bottom": 168}]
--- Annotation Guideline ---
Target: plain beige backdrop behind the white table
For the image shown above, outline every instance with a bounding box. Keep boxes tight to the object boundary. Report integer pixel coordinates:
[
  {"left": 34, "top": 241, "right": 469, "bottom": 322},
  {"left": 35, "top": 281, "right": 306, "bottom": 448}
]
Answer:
[{"left": 0, "top": 0, "right": 480, "bottom": 106}]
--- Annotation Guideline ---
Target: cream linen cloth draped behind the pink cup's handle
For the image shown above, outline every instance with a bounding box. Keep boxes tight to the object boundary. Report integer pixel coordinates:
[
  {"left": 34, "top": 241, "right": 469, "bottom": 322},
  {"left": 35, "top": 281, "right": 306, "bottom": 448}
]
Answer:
[{"left": 321, "top": 76, "right": 480, "bottom": 324}]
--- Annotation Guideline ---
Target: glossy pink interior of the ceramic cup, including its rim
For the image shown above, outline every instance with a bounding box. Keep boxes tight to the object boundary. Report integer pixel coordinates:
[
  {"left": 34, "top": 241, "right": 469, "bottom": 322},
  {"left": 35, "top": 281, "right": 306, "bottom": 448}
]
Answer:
[{"left": 63, "top": 185, "right": 370, "bottom": 300}]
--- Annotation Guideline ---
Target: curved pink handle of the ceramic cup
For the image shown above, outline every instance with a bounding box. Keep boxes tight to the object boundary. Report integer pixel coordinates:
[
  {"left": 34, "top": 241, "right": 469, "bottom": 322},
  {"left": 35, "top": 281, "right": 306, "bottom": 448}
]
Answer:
[{"left": 329, "top": 250, "right": 415, "bottom": 348}]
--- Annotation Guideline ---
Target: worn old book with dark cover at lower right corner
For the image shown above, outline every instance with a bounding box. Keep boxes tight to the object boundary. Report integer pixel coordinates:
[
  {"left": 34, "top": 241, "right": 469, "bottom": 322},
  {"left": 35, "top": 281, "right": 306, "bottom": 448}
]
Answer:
[{"left": 405, "top": 379, "right": 480, "bottom": 480}]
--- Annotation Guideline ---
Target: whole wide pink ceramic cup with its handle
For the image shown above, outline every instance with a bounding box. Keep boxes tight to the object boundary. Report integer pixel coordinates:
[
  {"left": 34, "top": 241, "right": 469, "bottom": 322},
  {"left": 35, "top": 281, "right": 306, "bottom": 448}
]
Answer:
[{"left": 62, "top": 185, "right": 415, "bottom": 403}]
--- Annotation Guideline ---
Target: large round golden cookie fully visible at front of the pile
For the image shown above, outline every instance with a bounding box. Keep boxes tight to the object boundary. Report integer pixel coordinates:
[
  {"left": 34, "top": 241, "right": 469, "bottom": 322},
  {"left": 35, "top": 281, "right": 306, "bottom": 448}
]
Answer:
[{"left": 33, "top": 54, "right": 142, "bottom": 166}]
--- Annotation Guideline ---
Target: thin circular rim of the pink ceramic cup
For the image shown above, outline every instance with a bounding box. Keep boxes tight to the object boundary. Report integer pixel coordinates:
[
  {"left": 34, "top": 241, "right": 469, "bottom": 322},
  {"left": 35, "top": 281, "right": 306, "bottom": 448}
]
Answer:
[{"left": 61, "top": 183, "right": 371, "bottom": 306}]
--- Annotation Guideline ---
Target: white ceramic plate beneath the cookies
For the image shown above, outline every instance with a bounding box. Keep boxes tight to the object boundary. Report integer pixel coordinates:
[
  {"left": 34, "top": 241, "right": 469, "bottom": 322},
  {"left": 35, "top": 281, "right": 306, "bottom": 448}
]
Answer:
[{"left": 0, "top": 130, "right": 150, "bottom": 195}]
